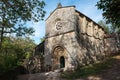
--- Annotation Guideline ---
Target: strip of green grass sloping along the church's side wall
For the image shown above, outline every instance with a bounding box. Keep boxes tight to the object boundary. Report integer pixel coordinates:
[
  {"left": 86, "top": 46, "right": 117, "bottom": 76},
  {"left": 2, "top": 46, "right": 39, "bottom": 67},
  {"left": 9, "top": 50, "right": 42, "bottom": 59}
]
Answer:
[{"left": 61, "top": 57, "right": 115, "bottom": 80}]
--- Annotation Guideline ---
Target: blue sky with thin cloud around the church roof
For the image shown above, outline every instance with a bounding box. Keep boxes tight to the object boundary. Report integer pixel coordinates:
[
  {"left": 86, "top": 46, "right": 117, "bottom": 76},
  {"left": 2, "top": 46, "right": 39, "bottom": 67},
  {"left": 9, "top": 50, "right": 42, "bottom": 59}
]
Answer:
[{"left": 30, "top": 0, "right": 103, "bottom": 44}]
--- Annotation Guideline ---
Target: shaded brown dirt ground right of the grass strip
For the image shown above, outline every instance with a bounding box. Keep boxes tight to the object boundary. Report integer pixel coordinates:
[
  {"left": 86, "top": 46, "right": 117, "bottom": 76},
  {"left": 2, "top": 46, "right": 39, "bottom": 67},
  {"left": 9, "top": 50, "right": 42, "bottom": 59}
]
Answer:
[{"left": 76, "top": 55, "right": 120, "bottom": 80}]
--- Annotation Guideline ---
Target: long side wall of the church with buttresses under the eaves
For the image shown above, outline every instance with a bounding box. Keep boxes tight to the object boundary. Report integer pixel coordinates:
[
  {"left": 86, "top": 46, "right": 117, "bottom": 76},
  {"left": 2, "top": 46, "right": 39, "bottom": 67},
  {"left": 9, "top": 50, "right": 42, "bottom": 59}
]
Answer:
[{"left": 76, "top": 12, "right": 105, "bottom": 66}]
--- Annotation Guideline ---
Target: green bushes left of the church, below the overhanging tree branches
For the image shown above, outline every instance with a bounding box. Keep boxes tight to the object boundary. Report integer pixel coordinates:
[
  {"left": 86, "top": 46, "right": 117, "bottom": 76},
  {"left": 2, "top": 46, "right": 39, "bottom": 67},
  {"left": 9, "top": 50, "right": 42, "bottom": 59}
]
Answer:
[{"left": 0, "top": 37, "right": 36, "bottom": 74}]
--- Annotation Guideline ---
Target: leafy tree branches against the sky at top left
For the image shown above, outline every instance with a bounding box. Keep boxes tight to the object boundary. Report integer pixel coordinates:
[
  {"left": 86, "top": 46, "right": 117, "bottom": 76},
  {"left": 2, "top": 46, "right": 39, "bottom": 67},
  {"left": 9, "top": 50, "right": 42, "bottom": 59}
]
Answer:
[{"left": 0, "top": 0, "right": 45, "bottom": 47}]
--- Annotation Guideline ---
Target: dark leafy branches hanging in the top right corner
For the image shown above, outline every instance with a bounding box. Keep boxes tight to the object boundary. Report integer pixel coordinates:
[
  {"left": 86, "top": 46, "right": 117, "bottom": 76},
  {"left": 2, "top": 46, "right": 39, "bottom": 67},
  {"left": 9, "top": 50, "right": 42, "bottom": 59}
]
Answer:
[{"left": 96, "top": 0, "right": 120, "bottom": 29}]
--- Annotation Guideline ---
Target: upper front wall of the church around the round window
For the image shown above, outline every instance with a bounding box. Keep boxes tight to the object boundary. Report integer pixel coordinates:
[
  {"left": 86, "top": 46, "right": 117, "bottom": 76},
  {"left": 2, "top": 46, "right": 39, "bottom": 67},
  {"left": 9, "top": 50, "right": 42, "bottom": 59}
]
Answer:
[{"left": 45, "top": 7, "right": 76, "bottom": 38}]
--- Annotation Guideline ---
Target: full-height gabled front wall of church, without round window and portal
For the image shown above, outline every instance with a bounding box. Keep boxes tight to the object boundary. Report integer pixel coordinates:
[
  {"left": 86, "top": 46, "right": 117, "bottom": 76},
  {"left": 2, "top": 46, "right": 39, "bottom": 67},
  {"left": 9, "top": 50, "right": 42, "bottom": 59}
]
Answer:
[{"left": 45, "top": 7, "right": 76, "bottom": 68}]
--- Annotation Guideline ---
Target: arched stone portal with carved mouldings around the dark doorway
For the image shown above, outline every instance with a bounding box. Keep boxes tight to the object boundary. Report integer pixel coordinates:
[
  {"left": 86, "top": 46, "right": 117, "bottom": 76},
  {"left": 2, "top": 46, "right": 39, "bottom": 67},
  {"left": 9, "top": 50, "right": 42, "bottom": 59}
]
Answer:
[{"left": 52, "top": 46, "right": 67, "bottom": 70}]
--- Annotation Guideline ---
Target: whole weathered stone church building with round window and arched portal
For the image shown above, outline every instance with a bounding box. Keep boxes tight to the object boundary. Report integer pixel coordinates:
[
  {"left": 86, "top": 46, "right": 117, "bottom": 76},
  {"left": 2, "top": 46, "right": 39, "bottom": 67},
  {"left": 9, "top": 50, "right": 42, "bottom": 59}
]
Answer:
[{"left": 41, "top": 5, "right": 118, "bottom": 70}]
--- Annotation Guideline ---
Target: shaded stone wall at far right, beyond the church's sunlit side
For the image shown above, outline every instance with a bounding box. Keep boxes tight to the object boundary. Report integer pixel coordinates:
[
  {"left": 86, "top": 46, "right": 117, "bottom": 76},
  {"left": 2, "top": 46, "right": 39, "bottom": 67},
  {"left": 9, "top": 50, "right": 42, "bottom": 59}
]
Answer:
[{"left": 104, "top": 34, "right": 120, "bottom": 56}]
